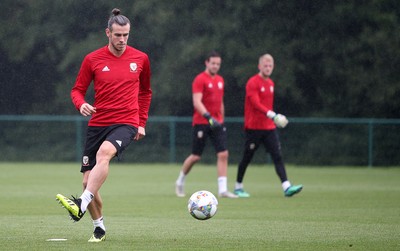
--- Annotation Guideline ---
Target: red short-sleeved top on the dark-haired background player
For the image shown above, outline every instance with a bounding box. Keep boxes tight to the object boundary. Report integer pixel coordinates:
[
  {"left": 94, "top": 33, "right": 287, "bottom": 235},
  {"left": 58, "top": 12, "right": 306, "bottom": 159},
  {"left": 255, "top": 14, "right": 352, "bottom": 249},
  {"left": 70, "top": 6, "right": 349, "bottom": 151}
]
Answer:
[{"left": 192, "top": 71, "right": 224, "bottom": 125}]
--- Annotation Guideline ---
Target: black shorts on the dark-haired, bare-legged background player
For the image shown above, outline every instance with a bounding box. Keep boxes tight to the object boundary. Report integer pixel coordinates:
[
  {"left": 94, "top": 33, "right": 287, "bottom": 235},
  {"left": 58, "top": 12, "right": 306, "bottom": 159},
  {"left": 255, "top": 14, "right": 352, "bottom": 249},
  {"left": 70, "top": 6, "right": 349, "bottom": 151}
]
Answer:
[{"left": 192, "top": 125, "right": 226, "bottom": 156}]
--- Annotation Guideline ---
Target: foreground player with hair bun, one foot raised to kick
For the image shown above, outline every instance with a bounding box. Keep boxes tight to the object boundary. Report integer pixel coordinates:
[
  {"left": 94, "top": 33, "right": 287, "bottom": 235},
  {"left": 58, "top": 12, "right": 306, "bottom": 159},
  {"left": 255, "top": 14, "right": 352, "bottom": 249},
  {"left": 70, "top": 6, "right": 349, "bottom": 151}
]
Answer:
[{"left": 56, "top": 9, "right": 152, "bottom": 242}]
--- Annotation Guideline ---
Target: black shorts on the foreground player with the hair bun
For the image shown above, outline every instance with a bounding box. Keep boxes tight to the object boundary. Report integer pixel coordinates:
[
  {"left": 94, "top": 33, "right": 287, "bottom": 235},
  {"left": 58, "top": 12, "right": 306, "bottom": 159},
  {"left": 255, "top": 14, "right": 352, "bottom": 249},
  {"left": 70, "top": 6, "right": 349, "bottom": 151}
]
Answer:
[{"left": 81, "top": 124, "right": 137, "bottom": 173}]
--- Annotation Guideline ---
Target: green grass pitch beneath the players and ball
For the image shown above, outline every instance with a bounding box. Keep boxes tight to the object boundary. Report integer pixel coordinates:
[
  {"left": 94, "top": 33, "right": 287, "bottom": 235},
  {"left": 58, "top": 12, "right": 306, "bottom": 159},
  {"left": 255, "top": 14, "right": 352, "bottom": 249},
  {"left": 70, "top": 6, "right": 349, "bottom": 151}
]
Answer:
[{"left": 0, "top": 163, "right": 400, "bottom": 250}]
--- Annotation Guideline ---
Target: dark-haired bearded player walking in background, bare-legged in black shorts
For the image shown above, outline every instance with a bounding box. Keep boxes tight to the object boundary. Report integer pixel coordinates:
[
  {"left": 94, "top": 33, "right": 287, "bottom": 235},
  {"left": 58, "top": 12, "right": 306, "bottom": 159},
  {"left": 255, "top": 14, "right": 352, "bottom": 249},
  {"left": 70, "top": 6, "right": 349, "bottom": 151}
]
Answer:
[{"left": 175, "top": 52, "right": 237, "bottom": 198}]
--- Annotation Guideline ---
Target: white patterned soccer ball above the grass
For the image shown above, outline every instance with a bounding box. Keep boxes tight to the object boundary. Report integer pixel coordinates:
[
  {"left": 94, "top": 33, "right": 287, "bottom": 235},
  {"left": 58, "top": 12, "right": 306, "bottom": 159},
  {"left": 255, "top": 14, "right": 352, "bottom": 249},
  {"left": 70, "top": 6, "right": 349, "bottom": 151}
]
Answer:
[{"left": 188, "top": 190, "right": 218, "bottom": 220}]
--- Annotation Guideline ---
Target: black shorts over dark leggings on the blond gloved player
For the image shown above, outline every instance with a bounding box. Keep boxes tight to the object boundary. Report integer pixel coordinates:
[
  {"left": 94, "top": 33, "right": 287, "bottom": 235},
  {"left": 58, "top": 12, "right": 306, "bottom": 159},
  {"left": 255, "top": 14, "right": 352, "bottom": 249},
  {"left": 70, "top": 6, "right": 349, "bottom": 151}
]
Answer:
[{"left": 245, "top": 129, "right": 281, "bottom": 154}]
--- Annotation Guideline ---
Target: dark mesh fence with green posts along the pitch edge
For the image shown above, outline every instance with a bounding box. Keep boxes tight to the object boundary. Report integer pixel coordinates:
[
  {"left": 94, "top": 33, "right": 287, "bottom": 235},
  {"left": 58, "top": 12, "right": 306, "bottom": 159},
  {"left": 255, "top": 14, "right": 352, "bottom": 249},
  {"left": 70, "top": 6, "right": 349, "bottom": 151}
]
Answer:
[{"left": 0, "top": 116, "right": 400, "bottom": 166}]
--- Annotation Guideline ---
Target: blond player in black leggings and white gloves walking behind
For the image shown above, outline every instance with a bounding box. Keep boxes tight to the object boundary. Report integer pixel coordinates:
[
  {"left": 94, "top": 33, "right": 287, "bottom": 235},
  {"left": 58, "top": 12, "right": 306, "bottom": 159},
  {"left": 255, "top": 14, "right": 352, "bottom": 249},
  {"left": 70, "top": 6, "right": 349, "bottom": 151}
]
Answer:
[{"left": 234, "top": 54, "right": 303, "bottom": 198}]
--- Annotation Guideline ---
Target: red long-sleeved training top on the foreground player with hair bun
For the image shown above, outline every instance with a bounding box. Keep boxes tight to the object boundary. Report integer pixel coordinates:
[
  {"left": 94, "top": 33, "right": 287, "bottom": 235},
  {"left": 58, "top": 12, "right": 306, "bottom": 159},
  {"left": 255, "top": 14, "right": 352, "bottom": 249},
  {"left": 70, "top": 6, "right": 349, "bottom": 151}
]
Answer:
[{"left": 71, "top": 46, "right": 152, "bottom": 127}]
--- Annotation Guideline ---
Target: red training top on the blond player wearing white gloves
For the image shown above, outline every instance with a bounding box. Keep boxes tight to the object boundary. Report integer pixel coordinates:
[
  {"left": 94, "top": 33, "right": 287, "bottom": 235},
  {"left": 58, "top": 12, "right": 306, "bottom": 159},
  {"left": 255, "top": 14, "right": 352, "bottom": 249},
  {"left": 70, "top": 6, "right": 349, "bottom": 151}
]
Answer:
[{"left": 244, "top": 74, "right": 276, "bottom": 130}]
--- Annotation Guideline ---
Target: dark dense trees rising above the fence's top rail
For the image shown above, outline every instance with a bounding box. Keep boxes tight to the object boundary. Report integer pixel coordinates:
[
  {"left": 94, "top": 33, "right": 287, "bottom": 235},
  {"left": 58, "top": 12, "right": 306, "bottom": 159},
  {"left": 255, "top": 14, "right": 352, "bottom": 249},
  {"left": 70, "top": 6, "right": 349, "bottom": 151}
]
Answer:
[{"left": 0, "top": 0, "right": 400, "bottom": 118}]
